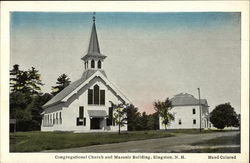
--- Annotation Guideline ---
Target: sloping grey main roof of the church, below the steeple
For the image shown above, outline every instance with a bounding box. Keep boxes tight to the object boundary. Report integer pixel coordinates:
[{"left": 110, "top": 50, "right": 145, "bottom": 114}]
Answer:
[{"left": 43, "top": 70, "right": 107, "bottom": 108}]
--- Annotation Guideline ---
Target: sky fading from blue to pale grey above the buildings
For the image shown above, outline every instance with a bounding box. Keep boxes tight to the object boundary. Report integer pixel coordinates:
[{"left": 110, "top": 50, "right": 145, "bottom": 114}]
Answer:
[{"left": 10, "top": 12, "right": 241, "bottom": 113}]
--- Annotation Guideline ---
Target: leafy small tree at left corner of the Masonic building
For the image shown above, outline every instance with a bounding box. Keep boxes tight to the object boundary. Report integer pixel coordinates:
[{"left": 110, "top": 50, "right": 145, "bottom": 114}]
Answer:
[{"left": 154, "top": 98, "right": 174, "bottom": 130}]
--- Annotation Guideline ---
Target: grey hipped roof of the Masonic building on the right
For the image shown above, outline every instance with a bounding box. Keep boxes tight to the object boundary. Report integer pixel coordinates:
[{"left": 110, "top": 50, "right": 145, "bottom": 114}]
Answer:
[{"left": 170, "top": 93, "right": 208, "bottom": 106}]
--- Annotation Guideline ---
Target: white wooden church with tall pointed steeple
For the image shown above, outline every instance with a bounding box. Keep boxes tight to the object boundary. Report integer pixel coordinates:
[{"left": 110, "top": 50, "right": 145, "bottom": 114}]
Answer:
[{"left": 41, "top": 17, "right": 129, "bottom": 132}]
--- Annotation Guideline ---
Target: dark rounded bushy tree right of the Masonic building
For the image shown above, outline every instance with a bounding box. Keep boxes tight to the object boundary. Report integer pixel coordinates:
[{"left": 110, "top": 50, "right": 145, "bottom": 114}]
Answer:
[{"left": 210, "top": 103, "right": 239, "bottom": 129}]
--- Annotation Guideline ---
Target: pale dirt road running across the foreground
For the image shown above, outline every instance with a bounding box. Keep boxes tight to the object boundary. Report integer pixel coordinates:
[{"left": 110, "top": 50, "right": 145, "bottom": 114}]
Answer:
[{"left": 46, "top": 131, "right": 239, "bottom": 153}]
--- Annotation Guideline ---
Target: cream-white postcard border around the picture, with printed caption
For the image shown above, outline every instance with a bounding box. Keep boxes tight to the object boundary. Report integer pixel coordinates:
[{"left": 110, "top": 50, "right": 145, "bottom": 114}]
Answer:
[{"left": 0, "top": 1, "right": 249, "bottom": 163}]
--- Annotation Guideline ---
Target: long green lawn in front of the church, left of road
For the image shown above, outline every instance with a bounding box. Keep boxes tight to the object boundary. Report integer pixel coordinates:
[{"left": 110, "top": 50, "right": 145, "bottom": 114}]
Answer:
[{"left": 10, "top": 131, "right": 174, "bottom": 152}]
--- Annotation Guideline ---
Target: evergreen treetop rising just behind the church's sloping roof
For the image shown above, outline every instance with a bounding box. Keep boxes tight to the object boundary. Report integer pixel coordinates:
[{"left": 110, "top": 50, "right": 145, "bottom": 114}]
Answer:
[{"left": 51, "top": 74, "right": 70, "bottom": 96}]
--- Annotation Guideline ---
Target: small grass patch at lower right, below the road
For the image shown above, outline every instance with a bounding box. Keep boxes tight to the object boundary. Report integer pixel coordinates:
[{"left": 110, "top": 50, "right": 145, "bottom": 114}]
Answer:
[{"left": 191, "top": 134, "right": 240, "bottom": 146}]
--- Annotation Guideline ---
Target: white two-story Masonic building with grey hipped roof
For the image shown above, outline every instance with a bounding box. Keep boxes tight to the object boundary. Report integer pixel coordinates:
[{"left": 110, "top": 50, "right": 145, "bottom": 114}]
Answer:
[{"left": 159, "top": 93, "right": 210, "bottom": 130}]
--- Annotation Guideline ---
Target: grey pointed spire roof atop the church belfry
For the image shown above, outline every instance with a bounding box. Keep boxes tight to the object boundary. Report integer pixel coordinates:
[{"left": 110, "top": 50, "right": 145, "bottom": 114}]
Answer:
[{"left": 82, "top": 18, "right": 106, "bottom": 60}]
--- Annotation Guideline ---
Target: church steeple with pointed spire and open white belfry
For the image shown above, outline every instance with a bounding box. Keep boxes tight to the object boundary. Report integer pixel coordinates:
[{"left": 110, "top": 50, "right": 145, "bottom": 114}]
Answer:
[{"left": 81, "top": 13, "right": 106, "bottom": 70}]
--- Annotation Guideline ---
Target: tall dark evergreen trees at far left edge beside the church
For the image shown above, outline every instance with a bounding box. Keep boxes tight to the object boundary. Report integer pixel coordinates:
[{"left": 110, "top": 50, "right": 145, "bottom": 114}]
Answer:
[{"left": 10, "top": 64, "right": 51, "bottom": 131}]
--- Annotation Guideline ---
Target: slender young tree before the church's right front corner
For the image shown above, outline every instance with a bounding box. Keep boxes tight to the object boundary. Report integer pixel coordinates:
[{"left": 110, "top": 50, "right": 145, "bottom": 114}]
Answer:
[{"left": 111, "top": 103, "right": 127, "bottom": 134}]
